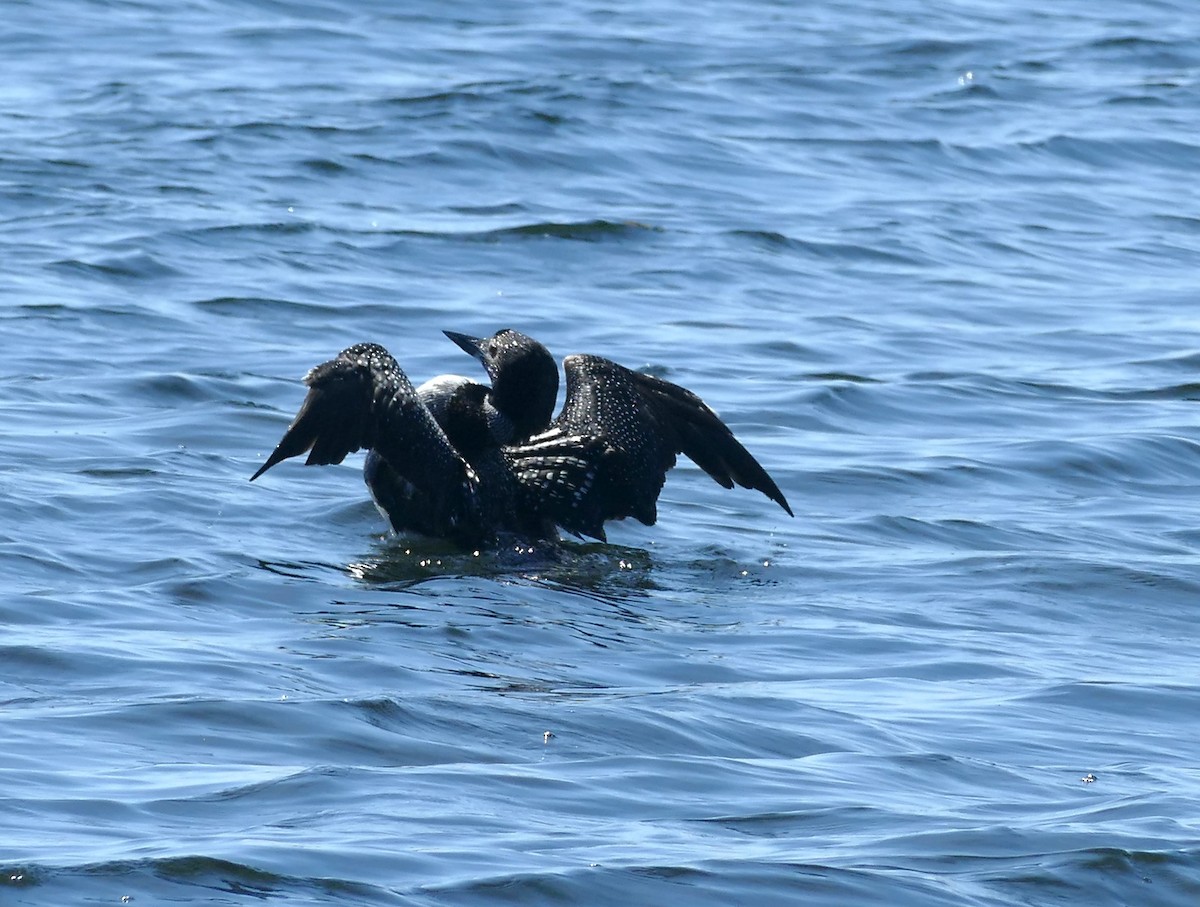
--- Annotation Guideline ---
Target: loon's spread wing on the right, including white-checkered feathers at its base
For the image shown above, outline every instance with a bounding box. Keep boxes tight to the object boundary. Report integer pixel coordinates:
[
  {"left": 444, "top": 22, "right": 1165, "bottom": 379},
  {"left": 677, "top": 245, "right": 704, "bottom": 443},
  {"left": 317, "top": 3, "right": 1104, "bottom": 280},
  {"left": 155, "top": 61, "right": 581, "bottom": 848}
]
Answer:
[{"left": 505, "top": 355, "right": 792, "bottom": 541}]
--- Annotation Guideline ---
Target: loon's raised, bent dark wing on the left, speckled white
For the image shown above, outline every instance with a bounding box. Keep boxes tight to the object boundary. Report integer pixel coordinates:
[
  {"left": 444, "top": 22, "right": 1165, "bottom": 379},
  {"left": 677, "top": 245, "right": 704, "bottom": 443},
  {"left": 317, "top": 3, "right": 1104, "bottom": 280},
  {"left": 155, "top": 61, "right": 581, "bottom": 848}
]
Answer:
[{"left": 251, "top": 343, "right": 478, "bottom": 533}]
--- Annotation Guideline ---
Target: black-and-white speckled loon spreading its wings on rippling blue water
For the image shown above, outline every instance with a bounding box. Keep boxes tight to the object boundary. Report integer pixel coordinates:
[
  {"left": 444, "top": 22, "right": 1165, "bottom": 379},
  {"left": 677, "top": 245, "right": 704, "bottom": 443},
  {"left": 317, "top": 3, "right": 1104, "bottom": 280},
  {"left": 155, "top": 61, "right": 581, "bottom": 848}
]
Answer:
[{"left": 251, "top": 329, "right": 792, "bottom": 548}]
